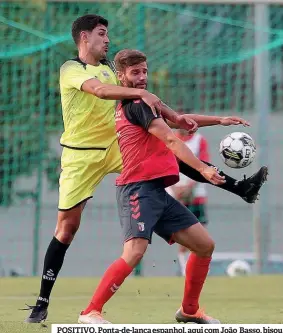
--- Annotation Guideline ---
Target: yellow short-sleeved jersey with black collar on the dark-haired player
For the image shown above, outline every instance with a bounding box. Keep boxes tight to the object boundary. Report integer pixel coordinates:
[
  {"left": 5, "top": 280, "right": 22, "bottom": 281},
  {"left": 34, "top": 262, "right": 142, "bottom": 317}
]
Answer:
[{"left": 60, "top": 58, "right": 118, "bottom": 149}]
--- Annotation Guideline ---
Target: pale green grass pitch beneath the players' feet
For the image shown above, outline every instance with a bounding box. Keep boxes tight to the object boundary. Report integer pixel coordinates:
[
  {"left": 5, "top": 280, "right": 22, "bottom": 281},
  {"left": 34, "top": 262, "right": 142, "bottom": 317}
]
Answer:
[{"left": 0, "top": 275, "right": 283, "bottom": 333}]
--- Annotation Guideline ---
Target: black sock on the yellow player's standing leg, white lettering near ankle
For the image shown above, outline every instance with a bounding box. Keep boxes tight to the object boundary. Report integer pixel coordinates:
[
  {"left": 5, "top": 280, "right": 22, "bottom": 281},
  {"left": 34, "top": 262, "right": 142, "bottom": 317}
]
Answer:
[{"left": 36, "top": 237, "right": 70, "bottom": 306}]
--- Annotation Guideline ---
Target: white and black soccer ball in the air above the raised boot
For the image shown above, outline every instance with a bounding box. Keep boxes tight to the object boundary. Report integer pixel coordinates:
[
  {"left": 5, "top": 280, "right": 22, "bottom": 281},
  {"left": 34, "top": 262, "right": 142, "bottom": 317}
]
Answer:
[{"left": 219, "top": 132, "right": 256, "bottom": 169}]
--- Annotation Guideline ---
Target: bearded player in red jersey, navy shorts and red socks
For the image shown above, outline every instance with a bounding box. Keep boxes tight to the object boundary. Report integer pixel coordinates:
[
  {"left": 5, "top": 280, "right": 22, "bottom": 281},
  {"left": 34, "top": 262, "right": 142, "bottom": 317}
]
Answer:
[{"left": 78, "top": 50, "right": 229, "bottom": 324}]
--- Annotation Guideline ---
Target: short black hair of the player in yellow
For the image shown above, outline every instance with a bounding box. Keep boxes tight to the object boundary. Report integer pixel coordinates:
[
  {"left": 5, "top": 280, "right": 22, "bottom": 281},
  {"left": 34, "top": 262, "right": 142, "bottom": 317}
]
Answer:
[{"left": 72, "top": 14, "right": 108, "bottom": 45}]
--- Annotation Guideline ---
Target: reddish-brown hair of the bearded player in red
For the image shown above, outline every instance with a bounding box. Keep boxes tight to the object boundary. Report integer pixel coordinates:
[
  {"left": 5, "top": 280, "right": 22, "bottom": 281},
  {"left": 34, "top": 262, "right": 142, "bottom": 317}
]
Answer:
[{"left": 114, "top": 49, "right": 146, "bottom": 72}]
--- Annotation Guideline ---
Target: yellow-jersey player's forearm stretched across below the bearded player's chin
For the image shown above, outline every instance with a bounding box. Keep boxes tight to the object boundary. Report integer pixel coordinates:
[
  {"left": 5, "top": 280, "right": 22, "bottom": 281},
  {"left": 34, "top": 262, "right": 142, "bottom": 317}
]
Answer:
[{"left": 93, "top": 84, "right": 143, "bottom": 100}]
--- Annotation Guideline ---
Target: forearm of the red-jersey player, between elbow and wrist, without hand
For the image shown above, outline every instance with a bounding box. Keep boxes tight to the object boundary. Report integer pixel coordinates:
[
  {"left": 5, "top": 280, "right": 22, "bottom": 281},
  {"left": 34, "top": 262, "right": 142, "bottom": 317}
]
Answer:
[{"left": 166, "top": 135, "right": 206, "bottom": 172}]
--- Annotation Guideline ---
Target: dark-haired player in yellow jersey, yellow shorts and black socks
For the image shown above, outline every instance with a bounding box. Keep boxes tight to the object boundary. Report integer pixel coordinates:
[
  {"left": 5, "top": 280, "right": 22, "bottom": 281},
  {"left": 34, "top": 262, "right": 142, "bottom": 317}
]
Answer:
[{"left": 26, "top": 15, "right": 268, "bottom": 323}]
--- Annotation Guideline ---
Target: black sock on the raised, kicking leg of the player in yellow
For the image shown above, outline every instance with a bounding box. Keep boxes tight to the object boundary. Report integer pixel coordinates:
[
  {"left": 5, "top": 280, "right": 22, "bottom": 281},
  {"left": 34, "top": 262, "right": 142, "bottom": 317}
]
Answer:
[{"left": 179, "top": 161, "right": 243, "bottom": 196}]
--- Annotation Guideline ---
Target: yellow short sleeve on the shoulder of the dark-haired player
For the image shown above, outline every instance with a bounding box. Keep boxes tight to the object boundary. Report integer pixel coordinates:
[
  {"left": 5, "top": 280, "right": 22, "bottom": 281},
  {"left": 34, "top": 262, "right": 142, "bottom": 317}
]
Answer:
[{"left": 60, "top": 61, "right": 95, "bottom": 90}]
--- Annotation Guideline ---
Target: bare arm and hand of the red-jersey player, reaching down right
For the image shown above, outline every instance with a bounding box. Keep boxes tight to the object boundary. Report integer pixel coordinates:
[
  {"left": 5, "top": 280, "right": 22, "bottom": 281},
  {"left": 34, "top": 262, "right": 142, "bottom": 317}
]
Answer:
[{"left": 148, "top": 118, "right": 225, "bottom": 184}]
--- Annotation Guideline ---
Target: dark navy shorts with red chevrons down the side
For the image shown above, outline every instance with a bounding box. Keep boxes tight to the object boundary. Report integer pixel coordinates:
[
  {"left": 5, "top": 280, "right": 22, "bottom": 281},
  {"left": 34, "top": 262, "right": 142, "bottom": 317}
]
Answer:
[{"left": 116, "top": 179, "right": 198, "bottom": 244}]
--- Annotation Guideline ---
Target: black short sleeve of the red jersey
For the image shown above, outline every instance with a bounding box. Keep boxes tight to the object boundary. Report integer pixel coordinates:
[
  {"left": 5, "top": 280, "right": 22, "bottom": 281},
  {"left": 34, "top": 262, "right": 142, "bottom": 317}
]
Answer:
[{"left": 124, "top": 100, "right": 161, "bottom": 130}]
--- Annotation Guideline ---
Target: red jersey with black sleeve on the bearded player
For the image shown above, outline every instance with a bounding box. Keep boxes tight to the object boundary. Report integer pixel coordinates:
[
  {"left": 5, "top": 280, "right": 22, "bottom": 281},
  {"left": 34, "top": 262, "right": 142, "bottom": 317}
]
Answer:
[{"left": 115, "top": 100, "right": 179, "bottom": 187}]
